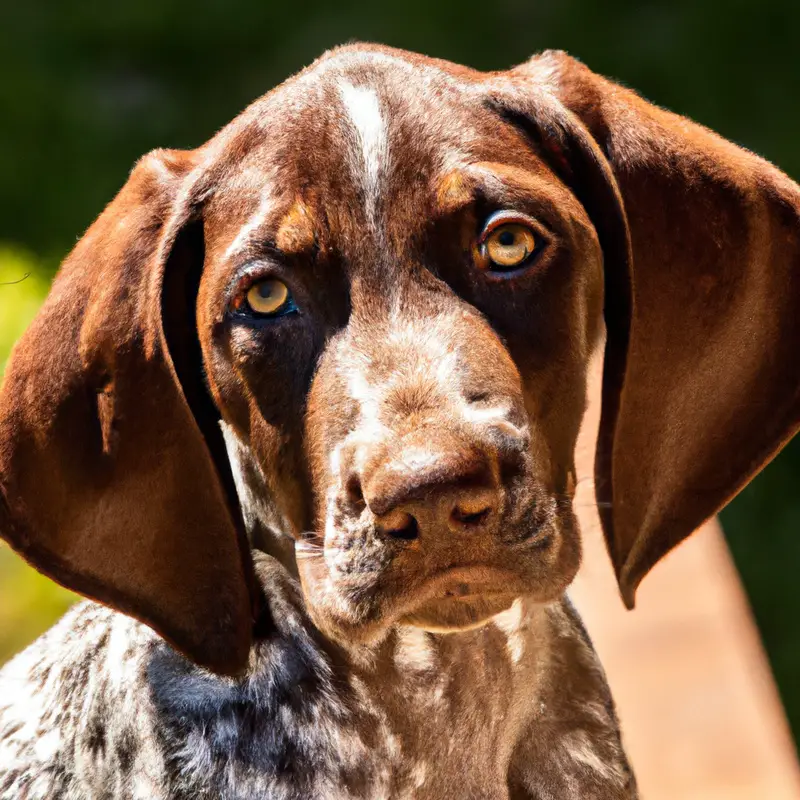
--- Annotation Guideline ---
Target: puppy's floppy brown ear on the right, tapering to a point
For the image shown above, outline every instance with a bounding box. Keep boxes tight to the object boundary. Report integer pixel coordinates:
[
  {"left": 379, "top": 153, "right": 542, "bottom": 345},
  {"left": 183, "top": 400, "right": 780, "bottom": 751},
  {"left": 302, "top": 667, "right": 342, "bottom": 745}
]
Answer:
[{"left": 500, "top": 53, "right": 800, "bottom": 607}]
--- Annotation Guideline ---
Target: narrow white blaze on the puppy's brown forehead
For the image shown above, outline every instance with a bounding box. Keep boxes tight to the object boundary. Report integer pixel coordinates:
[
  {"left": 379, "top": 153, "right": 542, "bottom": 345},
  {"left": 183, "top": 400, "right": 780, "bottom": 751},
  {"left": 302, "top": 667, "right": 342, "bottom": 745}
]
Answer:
[{"left": 339, "top": 83, "right": 387, "bottom": 218}]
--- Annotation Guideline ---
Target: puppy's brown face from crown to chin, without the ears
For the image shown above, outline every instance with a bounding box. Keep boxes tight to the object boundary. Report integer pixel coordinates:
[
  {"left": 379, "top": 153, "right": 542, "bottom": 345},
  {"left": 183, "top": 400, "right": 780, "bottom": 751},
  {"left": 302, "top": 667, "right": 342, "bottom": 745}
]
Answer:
[{"left": 198, "top": 53, "right": 602, "bottom": 639}]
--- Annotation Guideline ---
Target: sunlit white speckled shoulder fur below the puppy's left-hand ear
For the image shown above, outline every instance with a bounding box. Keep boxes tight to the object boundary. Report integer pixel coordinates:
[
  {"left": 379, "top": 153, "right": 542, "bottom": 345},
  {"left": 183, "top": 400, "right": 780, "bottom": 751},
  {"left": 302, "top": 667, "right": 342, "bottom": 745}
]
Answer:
[{"left": 0, "top": 602, "right": 169, "bottom": 800}]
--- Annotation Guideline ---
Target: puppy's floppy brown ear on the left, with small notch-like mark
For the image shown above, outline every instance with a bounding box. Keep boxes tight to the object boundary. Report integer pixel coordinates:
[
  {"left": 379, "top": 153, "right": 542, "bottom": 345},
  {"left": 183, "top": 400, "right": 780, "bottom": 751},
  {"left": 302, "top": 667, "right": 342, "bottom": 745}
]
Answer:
[{"left": 0, "top": 151, "right": 256, "bottom": 674}]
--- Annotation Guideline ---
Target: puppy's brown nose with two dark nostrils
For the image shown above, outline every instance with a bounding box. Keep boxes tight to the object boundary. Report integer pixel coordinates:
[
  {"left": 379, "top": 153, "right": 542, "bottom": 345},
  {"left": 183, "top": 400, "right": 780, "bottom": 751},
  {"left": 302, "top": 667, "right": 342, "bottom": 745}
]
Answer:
[{"left": 358, "top": 432, "right": 500, "bottom": 539}]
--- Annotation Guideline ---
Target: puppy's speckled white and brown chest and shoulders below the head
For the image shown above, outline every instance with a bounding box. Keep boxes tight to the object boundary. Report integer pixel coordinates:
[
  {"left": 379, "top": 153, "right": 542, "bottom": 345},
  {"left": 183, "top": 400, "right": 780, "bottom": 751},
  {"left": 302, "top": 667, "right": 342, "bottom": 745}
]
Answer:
[{"left": 0, "top": 582, "right": 628, "bottom": 800}]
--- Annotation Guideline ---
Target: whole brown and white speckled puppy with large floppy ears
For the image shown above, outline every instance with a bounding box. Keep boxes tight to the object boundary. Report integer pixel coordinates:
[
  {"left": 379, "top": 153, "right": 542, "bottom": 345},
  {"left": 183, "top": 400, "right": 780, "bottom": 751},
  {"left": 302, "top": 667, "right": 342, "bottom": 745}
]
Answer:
[{"left": 0, "top": 45, "right": 800, "bottom": 800}]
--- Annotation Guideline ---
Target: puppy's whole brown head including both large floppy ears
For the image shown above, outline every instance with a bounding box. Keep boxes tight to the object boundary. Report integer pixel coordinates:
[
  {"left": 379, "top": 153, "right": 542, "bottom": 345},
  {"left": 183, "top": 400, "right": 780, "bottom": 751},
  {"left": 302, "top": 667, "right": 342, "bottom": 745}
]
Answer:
[{"left": 0, "top": 47, "right": 800, "bottom": 672}]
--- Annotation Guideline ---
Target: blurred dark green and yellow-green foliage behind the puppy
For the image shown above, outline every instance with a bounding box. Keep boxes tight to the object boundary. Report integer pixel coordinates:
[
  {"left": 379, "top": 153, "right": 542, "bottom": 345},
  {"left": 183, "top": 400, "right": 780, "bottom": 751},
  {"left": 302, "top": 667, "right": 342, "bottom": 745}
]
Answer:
[{"left": 0, "top": 0, "right": 800, "bottom": 734}]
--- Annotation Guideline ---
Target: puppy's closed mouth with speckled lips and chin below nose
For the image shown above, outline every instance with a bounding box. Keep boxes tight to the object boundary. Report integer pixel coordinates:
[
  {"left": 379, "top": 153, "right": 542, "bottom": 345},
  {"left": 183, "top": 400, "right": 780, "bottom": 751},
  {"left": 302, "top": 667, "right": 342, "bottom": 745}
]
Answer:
[{"left": 295, "top": 504, "right": 580, "bottom": 642}]
